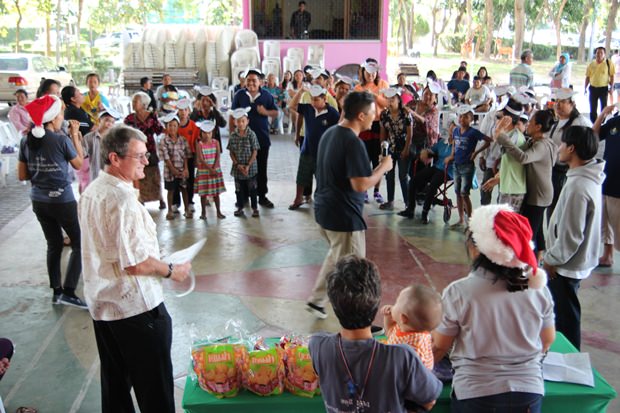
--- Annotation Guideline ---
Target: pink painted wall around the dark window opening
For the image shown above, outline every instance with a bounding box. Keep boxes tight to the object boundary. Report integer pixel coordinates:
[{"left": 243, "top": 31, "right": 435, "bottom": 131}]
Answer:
[{"left": 243, "top": 0, "right": 389, "bottom": 79}]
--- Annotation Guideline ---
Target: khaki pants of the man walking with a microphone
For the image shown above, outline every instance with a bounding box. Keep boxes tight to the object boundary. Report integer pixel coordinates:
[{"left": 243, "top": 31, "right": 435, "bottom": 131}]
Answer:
[{"left": 308, "top": 228, "right": 366, "bottom": 307}]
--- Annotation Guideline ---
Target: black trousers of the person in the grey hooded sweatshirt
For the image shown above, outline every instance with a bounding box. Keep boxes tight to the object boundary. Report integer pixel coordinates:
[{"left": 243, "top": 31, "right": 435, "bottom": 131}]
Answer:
[{"left": 547, "top": 274, "right": 581, "bottom": 350}]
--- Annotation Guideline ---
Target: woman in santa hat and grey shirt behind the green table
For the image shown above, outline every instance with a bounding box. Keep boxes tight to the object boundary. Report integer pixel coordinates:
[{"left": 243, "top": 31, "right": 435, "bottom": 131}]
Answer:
[{"left": 433, "top": 205, "right": 555, "bottom": 413}]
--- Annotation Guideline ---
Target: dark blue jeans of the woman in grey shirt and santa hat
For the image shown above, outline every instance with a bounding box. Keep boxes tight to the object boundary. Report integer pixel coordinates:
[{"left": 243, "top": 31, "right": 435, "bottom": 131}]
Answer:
[{"left": 450, "top": 392, "right": 542, "bottom": 413}]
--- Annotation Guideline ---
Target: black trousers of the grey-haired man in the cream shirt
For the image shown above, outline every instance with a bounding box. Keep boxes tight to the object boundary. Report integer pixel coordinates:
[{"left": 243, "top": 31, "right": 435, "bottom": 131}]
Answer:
[{"left": 93, "top": 303, "right": 175, "bottom": 413}]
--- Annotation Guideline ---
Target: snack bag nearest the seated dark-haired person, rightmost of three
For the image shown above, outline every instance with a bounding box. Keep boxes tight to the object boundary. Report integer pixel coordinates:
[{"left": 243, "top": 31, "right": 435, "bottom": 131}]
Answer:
[{"left": 284, "top": 345, "right": 320, "bottom": 397}]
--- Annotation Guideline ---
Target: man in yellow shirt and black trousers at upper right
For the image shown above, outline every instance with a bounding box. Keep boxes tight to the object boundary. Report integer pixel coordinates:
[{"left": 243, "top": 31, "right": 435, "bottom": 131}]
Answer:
[{"left": 584, "top": 46, "right": 616, "bottom": 123}]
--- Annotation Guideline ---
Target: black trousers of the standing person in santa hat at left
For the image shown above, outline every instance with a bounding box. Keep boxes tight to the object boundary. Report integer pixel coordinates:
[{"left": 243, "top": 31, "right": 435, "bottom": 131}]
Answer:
[{"left": 32, "top": 201, "right": 82, "bottom": 290}]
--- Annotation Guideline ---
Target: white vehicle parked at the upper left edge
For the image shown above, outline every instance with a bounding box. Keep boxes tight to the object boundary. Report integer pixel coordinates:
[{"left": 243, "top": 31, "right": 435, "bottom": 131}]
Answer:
[{"left": 0, "top": 53, "right": 75, "bottom": 103}]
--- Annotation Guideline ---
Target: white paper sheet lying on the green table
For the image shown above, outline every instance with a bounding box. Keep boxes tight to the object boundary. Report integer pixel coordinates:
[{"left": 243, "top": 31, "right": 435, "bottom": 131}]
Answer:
[{"left": 543, "top": 352, "right": 594, "bottom": 387}]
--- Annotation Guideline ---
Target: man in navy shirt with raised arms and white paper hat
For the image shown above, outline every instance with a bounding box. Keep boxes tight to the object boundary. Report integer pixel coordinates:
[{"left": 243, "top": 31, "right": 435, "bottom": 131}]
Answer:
[{"left": 288, "top": 85, "right": 340, "bottom": 210}]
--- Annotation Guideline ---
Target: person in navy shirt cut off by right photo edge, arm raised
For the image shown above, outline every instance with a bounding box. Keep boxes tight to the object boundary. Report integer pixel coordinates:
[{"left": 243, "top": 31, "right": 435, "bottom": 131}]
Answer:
[{"left": 592, "top": 105, "right": 620, "bottom": 267}]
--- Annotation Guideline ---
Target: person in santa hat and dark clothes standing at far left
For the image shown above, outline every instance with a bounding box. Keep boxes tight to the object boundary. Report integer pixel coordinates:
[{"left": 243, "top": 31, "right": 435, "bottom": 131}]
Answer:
[{"left": 18, "top": 95, "right": 87, "bottom": 309}]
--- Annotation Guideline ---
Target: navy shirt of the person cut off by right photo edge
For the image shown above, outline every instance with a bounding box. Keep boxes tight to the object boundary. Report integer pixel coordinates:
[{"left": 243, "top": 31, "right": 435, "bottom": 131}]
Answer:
[{"left": 599, "top": 115, "right": 620, "bottom": 198}]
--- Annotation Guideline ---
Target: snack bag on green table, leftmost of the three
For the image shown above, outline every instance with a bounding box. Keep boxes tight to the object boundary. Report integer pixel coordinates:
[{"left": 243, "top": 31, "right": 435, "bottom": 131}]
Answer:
[{"left": 192, "top": 344, "right": 246, "bottom": 398}]
